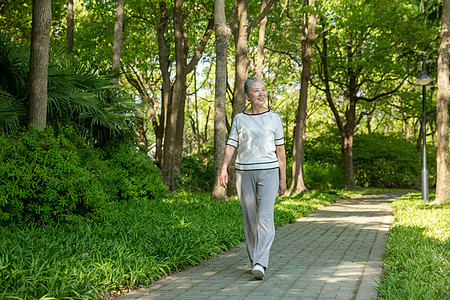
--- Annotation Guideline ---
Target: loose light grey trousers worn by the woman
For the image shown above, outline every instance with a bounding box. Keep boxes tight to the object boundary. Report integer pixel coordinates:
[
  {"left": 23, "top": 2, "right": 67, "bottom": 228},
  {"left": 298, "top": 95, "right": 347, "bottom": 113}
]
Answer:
[{"left": 236, "top": 169, "right": 280, "bottom": 268}]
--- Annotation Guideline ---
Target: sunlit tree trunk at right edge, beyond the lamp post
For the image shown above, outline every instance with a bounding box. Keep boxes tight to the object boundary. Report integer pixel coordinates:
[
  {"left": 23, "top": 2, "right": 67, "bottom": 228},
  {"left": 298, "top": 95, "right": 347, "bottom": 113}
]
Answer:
[{"left": 432, "top": 0, "right": 450, "bottom": 204}]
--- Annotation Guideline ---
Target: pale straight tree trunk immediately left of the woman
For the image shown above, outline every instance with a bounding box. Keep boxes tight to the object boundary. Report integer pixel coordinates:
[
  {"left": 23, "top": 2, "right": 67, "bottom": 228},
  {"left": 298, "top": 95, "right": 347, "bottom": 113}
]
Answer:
[{"left": 211, "top": 0, "right": 231, "bottom": 201}]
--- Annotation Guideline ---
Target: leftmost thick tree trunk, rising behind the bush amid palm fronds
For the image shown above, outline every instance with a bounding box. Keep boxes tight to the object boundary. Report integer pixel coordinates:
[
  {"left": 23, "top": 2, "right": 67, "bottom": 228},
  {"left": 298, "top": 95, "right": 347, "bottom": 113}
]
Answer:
[{"left": 28, "top": 0, "right": 52, "bottom": 130}]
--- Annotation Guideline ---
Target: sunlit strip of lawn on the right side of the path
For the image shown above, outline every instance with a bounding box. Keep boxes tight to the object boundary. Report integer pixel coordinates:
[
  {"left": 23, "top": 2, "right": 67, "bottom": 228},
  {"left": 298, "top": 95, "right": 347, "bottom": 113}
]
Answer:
[{"left": 378, "top": 193, "right": 450, "bottom": 300}]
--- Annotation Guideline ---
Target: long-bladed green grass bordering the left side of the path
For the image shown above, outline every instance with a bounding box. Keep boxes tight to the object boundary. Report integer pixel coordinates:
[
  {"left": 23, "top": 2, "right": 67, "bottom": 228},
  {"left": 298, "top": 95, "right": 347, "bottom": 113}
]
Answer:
[{"left": 0, "top": 192, "right": 340, "bottom": 299}]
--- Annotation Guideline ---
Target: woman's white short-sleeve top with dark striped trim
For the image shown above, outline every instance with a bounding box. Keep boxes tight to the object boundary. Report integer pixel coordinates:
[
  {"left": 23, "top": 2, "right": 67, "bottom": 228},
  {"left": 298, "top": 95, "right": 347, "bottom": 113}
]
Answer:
[{"left": 227, "top": 110, "right": 284, "bottom": 171}]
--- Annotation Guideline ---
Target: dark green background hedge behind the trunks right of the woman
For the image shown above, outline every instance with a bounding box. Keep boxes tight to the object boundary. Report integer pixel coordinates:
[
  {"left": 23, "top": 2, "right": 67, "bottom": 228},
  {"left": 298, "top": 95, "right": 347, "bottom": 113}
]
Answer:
[{"left": 305, "top": 133, "right": 436, "bottom": 189}]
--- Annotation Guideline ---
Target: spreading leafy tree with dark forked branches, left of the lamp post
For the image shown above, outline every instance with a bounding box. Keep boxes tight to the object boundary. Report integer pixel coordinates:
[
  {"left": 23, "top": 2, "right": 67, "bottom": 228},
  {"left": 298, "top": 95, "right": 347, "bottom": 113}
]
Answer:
[{"left": 315, "top": 1, "right": 426, "bottom": 188}]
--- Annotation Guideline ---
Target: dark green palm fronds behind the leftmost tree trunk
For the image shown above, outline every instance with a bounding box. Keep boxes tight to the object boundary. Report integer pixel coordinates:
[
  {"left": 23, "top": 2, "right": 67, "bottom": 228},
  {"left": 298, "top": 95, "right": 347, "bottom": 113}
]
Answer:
[{"left": 0, "top": 32, "right": 140, "bottom": 145}]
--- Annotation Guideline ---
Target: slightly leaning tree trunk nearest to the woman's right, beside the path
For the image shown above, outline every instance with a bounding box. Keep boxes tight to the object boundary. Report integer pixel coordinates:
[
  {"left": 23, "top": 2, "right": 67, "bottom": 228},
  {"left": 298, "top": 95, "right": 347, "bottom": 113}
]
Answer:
[{"left": 290, "top": 0, "right": 318, "bottom": 194}]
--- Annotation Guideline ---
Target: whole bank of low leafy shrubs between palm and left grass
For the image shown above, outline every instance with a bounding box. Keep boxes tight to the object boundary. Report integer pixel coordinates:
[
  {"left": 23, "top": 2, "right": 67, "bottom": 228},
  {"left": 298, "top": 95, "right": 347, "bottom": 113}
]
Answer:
[{"left": 0, "top": 128, "right": 166, "bottom": 224}]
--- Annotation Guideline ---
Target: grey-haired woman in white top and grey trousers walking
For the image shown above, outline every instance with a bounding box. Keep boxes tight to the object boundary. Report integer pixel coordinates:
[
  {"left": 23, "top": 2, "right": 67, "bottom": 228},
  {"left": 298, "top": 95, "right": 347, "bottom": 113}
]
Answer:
[{"left": 220, "top": 77, "right": 286, "bottom": 280}]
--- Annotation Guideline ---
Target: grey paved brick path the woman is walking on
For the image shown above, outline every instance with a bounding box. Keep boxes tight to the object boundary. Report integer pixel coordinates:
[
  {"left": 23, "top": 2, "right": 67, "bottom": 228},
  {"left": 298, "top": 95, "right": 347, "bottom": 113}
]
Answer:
[{"left": 118, "top": 193, "right": 401, "bottom": 300}]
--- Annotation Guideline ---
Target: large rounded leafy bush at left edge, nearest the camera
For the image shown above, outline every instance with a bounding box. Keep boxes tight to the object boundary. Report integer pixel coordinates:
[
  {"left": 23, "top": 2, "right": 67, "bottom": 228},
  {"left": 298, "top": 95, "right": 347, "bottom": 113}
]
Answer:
[{"left": 0, "top": 129, "right": 107, "bottom": 224}]
